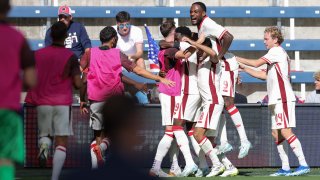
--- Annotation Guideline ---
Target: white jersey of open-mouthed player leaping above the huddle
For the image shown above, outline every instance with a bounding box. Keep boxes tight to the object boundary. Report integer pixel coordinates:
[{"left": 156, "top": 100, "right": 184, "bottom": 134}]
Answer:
[{"left": 198, "top": 16, "right": 227, "bottom": 57}]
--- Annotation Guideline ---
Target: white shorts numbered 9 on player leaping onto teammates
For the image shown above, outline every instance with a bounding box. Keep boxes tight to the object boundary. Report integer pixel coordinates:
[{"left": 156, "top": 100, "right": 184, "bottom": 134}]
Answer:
[{"left": 220, "top": 70, "right": 238, "bottom": 97}]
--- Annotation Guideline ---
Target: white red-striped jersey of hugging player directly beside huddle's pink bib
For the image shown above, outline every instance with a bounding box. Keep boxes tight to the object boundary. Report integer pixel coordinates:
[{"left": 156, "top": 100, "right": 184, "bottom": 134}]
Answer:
[{"left": 180, "top": 42, "right": 199, "bottom": 94}]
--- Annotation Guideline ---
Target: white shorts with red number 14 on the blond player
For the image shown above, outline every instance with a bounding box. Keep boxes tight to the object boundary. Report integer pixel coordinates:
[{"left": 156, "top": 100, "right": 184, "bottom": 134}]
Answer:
[{"left": 269, "top": 102, "right": 296, "bottom": 129}]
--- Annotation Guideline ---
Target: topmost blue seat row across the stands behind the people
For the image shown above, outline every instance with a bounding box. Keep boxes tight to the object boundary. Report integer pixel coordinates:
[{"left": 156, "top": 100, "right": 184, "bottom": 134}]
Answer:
[{"left": 9, "top": 6, "right": 320, "bottom": 18}]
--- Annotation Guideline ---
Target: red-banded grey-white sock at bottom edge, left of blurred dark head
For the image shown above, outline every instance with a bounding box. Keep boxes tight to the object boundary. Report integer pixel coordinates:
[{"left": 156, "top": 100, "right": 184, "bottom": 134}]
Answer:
[{"left": 51, "top": 146, "right": 66, "bottom": 180}]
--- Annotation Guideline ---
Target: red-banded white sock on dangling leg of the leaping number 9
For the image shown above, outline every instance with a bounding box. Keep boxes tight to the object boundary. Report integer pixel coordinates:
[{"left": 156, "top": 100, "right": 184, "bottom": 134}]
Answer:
[{"left": 226, "top": 105, "right": 248, "bottom": 142}]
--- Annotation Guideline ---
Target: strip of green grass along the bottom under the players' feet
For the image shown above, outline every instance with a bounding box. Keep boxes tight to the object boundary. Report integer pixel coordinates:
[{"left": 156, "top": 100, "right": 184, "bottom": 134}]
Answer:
[{"left": 16, "top": 168, "right": 320, "bottom": 180}]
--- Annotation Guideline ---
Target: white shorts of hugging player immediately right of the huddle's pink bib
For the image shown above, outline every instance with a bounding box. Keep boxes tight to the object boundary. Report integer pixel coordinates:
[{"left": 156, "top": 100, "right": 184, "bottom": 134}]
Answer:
[{"left": 173, "top": 94, "right": 201, "bottom": 122}]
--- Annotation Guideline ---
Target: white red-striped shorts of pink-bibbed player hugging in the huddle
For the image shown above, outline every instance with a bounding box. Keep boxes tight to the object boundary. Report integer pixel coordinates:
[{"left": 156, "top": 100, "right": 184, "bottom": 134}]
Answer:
[{"left": 159, "top": 93, "right": 180, "bottom": 126}]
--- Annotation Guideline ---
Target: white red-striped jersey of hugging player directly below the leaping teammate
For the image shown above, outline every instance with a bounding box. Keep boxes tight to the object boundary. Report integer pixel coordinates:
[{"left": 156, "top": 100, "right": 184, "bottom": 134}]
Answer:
[{"left": 198, "top": 57, "right": 224, "bottom": 104}]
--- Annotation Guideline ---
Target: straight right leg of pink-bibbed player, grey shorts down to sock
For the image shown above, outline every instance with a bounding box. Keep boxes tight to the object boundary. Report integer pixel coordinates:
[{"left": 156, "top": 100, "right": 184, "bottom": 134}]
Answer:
[{"left": 51, "top": 106, "right": 73, "bottom": 180}]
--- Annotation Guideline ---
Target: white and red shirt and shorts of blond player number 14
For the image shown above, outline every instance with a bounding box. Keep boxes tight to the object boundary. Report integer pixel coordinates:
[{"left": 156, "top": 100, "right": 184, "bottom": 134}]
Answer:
[{"left": 262, "top": 47, "right": 296, "bottom": 129}]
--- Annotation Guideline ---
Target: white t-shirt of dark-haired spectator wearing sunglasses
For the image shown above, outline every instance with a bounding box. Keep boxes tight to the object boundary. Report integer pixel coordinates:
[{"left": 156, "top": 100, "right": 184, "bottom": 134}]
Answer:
[{"left": 112, "top": 25, "right": 143, "bottom": 56}]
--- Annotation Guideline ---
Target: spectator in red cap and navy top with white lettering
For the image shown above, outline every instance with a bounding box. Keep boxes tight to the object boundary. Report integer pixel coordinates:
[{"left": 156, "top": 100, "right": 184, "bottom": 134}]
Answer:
[{"left": 44, "top": 5, "right": 91, "bottom": 59}]
